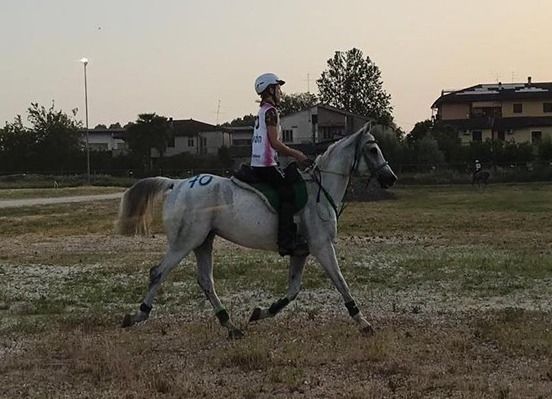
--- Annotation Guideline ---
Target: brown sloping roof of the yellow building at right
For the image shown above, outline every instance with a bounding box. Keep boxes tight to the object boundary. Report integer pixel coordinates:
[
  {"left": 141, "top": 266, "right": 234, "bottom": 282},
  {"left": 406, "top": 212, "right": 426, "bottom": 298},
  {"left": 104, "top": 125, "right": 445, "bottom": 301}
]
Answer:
[{"left": 431, "top": 82, "right": 552, "bottom": 108}]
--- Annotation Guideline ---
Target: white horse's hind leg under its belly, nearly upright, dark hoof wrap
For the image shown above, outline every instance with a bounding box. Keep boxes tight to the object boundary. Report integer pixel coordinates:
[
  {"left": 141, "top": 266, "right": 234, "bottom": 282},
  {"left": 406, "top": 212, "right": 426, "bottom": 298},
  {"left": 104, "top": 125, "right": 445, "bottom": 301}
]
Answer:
[{"left": 194, "top": 233, "right": 244, "bottom": 338}]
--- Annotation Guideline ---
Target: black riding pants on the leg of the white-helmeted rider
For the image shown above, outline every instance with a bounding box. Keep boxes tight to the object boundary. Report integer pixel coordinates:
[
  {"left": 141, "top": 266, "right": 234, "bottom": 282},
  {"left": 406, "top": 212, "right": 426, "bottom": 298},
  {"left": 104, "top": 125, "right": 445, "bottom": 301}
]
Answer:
[{"left": 253, "top": 166, "right": 297, "bottom": 247}]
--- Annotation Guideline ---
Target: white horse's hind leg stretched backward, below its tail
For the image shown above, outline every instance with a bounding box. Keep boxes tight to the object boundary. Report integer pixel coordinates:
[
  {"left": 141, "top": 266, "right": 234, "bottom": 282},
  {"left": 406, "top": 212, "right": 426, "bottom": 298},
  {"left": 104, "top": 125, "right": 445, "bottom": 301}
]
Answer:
[{"left": 123, "top": 249, "right": 189, "bottom": 327}]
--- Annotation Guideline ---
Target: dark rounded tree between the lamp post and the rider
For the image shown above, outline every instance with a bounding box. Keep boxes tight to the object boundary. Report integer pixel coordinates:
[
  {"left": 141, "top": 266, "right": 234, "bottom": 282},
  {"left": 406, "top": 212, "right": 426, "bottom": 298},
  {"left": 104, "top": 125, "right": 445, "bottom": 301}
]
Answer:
[{"left": 125, "top": 113, "right": 170, "bottom": 170}]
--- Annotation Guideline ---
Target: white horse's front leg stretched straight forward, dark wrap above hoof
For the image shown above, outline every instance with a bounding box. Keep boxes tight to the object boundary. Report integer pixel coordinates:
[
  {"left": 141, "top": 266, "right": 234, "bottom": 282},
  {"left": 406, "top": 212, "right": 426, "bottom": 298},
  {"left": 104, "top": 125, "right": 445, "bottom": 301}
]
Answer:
[{"left": 311, "top": 241, "right": 374, "bottom": 335}]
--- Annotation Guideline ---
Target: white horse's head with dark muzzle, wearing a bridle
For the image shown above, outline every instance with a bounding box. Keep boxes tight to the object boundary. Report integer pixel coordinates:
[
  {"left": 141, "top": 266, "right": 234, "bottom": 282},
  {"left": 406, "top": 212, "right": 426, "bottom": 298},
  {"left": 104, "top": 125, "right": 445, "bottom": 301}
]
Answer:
[{"left": 352, "top": 123, "right": 397, "bottom": 188}]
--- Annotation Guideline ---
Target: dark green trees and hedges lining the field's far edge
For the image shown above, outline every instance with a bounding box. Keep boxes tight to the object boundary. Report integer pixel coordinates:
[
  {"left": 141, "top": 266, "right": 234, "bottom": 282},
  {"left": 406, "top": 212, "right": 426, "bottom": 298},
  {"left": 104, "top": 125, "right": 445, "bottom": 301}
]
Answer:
[{"left": 0, "top": 48, "right": 552, "bottom": 174}]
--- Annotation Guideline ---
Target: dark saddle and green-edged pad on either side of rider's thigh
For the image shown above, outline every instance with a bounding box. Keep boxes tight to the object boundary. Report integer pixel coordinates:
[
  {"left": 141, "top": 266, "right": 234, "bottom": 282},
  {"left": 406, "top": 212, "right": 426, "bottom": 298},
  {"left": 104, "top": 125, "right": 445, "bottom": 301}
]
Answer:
[{"left": 230, "top": 162, "right": 308, "bottom": 213}]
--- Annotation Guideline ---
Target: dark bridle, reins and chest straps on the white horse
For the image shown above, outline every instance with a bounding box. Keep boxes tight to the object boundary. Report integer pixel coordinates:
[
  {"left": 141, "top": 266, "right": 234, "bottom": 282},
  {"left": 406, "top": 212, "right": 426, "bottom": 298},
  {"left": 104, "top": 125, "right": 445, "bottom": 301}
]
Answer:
[{"left": 310, "top": 135, "right": 389, "bottom": 219}]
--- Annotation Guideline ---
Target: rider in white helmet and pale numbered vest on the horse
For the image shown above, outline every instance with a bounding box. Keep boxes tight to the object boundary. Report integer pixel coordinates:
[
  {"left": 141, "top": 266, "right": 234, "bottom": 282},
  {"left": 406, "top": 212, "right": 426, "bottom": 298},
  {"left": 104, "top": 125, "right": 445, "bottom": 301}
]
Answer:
[{"left": 251, "top": 73, "right": 308, "bottom": 256}]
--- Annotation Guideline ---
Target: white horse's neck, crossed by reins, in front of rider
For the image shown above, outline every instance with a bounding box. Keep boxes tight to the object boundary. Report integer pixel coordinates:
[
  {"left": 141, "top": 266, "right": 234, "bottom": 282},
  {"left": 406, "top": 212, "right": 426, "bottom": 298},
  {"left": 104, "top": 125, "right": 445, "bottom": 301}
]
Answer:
[{"left": 318, "top": 142, "right": 354, "bottom": 206}]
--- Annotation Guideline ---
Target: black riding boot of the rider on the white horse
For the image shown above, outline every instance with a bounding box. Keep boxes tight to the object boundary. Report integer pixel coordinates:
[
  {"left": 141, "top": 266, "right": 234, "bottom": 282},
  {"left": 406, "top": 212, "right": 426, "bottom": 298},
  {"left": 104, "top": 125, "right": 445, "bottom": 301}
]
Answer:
[{"left": 278, "top": 201, "right": 309, "bottom": 256}]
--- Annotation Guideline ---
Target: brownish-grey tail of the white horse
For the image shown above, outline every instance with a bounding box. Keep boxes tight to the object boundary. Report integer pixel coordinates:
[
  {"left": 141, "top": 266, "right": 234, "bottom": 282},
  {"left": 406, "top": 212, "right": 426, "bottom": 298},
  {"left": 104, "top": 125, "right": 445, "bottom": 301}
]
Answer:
[{"left": 117, "top": 177, "right": 174, "bottom": 235}]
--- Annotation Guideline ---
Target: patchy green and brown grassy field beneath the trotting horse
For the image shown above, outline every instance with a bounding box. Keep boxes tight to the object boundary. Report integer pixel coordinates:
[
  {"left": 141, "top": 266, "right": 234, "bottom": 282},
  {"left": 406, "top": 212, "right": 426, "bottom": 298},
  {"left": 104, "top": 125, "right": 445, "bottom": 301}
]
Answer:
[{"left": 0, "top": 184, "right": 552, "bottom": 398}]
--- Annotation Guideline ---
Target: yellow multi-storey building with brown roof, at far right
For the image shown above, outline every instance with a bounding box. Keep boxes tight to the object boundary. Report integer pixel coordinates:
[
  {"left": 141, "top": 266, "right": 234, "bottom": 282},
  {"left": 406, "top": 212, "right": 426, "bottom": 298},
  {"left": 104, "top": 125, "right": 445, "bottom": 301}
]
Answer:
[{"left": 431, "top": 77, "right": 552, "bottom": 144}]
